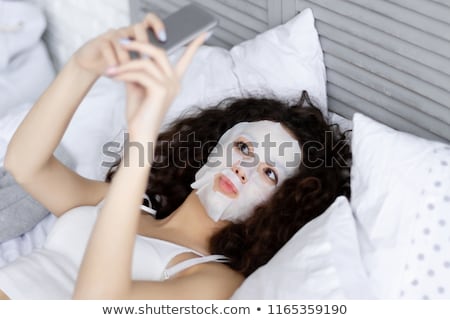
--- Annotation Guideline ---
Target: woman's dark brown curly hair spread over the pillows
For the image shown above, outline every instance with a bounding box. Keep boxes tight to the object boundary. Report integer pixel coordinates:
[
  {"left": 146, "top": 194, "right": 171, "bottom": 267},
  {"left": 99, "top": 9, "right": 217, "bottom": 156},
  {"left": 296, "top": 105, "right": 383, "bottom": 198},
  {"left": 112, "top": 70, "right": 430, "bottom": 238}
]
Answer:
[{"left": 108, "top": 92, "right": 351, "bottom": 276}]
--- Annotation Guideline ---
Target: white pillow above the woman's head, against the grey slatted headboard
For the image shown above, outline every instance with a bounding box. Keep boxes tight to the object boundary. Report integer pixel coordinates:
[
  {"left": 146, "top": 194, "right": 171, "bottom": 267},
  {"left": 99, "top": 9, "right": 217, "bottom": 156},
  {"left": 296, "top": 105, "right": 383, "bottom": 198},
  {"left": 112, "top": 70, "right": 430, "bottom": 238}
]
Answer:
[{"left": 165, "top": 9, "right": 327, "bottom": 124}]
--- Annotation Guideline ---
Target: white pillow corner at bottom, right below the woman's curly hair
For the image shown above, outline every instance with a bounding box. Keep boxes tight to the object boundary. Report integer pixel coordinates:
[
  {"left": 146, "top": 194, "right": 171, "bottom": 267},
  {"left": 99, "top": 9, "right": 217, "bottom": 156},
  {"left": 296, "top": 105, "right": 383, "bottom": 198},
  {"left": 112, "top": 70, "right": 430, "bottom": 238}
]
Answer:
[{"left": 232, "top": 196, "right": 373, "bottom": 299}]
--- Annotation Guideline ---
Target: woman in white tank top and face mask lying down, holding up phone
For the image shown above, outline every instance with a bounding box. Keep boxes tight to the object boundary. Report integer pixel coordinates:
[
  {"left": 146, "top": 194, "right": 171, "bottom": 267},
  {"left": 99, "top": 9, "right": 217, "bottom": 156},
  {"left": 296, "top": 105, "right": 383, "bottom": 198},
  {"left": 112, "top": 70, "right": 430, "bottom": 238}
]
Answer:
[{"left": 0, "top": 15, "right": 348, "bottom": 299}]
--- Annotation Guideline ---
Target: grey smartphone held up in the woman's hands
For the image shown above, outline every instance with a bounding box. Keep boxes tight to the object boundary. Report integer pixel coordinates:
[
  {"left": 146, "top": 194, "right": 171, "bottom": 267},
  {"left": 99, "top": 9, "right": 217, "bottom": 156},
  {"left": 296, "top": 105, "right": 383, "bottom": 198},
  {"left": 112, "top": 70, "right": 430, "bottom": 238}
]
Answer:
[{"left": 130, "top": 4, "right": 218, "bottom": 59}]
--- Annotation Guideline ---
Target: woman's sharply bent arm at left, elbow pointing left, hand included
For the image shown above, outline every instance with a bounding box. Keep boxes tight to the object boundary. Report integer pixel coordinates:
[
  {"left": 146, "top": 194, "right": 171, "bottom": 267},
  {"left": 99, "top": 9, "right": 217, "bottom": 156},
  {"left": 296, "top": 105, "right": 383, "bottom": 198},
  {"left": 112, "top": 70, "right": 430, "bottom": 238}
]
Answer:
[{"left": 4, "top": 25, "right": 161, "bottom": 215}]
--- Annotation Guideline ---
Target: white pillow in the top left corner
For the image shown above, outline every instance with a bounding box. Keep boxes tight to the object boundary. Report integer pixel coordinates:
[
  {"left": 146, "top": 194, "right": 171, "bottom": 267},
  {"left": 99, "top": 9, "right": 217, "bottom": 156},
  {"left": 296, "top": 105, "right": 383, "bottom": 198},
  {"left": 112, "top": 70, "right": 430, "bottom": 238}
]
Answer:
[{"left": 0, "top": 1, "right": 55, "bottom": 114}]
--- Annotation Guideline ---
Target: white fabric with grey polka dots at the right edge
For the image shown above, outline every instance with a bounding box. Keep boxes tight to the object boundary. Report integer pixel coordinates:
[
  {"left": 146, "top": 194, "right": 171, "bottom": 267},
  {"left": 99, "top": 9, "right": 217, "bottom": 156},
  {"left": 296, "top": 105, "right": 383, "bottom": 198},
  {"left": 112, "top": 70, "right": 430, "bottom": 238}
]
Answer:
[{"left": 399, "top": 146, "right": 450, "bottom": 299}]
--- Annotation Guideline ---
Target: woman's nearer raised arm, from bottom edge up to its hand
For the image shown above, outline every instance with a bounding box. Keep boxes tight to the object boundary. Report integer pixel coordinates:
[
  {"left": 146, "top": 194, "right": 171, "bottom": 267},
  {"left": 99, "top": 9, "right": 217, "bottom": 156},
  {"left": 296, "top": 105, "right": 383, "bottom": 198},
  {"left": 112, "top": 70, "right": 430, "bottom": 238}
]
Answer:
[{"left": 74, "top": 26, "right": 206, "bottom": 299}]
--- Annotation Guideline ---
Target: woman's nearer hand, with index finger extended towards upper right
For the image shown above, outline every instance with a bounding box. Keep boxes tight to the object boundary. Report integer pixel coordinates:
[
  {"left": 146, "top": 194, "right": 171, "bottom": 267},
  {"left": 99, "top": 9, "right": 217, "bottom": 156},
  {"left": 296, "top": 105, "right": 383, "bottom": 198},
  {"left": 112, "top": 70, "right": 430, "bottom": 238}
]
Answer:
[{"left": 108, "top": 34, "right": 206, "bottom": 142}]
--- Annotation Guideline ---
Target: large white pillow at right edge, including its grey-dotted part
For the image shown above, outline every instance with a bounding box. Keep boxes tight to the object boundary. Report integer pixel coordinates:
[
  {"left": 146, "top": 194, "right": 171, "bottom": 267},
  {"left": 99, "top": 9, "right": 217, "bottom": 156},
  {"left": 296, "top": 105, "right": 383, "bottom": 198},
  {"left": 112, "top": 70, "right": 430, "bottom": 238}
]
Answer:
[{"left": 351, "top": 114, "right": 450, "bottom": 299}]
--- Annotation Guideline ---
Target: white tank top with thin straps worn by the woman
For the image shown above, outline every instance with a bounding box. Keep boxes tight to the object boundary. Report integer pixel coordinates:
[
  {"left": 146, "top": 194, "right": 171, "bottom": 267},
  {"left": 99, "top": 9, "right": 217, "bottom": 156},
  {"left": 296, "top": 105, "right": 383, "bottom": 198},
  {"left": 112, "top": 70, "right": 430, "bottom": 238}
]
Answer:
[{"left": 0, "top": 202, "right": 226, "bottom": 299}]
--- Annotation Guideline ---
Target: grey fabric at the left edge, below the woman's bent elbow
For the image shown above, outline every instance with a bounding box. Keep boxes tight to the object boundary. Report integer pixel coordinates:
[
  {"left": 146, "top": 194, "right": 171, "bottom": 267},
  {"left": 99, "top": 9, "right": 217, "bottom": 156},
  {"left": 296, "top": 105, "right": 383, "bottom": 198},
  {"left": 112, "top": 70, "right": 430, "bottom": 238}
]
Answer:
[{"left": 0, "top": 167, "right": 49, "bottom": 242}]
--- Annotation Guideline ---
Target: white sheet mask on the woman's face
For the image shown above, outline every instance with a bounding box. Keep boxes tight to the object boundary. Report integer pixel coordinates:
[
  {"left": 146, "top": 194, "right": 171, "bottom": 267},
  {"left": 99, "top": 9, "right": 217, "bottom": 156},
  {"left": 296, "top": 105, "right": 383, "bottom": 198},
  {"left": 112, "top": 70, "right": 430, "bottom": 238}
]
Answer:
[{"left": 191, "top": 121, "right": 301, "bottom": 222}]
